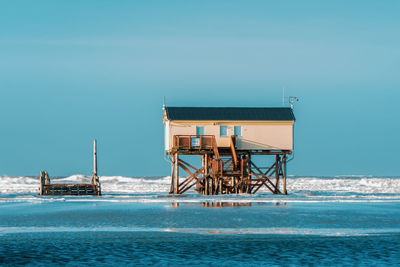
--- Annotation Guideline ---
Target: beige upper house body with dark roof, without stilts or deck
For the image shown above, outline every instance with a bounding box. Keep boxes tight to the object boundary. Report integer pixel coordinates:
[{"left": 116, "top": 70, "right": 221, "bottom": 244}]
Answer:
[{"left": 164, "top": 107, "right": 295, "bottom": 153}]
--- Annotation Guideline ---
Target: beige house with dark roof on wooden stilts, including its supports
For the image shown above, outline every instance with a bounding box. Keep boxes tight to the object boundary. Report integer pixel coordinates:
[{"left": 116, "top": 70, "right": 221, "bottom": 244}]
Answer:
[{"left": 163, "top": 107, "right": 295, "bottom": 195}]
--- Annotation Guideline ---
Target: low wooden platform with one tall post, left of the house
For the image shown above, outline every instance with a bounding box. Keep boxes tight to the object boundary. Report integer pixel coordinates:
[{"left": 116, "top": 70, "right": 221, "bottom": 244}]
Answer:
[{"left": 39, "top": 140, "right": 101, "bottom": 196}]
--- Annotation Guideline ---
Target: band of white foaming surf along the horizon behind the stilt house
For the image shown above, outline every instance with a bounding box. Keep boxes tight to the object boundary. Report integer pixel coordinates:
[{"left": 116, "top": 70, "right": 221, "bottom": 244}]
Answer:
[{"left": 0, "top": 174, "right": 400, "bottom": 197}]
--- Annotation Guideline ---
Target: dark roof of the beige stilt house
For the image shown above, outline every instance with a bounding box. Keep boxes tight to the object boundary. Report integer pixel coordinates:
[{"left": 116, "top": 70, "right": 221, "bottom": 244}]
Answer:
[{"left": 165, "top": 107, "right": 295, "bottom": 121}]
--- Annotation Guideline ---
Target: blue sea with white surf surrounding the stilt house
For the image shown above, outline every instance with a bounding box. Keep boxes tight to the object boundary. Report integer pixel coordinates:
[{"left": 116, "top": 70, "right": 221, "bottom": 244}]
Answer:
[{"left": 0, "top": 175, "right": 400, "bottom": 266}]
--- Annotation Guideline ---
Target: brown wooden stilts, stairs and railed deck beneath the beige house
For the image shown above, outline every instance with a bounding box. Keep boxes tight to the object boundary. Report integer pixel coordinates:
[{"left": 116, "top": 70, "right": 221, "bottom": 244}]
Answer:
[{"left": 169, "top": 135, "right": 292, "bottom": 195}]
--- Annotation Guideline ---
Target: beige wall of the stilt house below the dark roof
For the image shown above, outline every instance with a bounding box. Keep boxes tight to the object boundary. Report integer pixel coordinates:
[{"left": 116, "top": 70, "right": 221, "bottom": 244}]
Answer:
[{"left": 165, "top": 121, "right": 293, "bottom": 150}]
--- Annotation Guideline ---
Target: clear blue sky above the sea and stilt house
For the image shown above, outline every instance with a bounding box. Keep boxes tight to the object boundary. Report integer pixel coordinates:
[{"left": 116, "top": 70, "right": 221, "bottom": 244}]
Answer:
[{"left": 0, "top": 0, "right": 400, "bottom": 176}]
